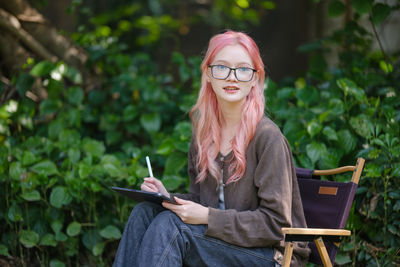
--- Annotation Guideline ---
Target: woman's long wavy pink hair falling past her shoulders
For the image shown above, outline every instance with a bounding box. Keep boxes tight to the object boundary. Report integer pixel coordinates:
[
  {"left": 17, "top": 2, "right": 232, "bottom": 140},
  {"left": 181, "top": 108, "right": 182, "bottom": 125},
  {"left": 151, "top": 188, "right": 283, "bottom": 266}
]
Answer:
[{"left": 190, "top": 31, "right": 265, "bottom": 183}]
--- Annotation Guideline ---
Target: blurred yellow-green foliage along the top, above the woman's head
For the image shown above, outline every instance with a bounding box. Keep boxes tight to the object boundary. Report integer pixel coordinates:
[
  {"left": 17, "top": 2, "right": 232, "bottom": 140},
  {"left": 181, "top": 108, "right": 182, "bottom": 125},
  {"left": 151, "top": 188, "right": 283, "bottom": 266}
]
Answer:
[{"left": 71, "top": 0, "right": 276, "bottom": 52}]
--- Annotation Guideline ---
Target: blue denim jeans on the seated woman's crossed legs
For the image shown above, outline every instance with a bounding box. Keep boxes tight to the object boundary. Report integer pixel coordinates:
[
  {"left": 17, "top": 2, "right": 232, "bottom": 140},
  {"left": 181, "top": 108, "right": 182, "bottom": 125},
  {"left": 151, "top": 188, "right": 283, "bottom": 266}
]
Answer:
[{"left": 113, "top": 202, "right": 279, "bottom": 267}]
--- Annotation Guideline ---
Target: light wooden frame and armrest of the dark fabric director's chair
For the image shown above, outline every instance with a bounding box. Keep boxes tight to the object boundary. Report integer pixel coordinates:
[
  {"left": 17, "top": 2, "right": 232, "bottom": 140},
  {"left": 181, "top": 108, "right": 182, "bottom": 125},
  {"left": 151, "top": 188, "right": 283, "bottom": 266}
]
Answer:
[{"left": 282, "top": 158, "right": 365, "bottom": 267}]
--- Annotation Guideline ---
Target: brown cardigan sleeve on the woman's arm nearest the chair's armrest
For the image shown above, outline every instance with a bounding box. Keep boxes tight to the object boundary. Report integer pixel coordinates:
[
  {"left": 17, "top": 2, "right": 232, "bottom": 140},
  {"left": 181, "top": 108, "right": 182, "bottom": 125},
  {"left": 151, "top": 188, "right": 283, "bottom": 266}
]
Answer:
[{"left": 206, "top": 130, "right": 293, "bottom": 247}]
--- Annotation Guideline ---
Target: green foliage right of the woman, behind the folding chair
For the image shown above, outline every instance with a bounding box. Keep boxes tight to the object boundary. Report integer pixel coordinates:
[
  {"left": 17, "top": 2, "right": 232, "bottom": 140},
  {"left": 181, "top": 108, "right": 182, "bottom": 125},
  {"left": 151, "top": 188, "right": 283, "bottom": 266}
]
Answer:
[{"left": 266, "top": 1, "right": 400, "bottom": 266}]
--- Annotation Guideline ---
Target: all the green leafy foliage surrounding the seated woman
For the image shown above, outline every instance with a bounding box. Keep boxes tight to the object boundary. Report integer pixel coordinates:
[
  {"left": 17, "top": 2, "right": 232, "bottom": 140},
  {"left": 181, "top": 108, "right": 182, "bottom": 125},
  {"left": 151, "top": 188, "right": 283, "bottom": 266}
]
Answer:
[{"left": 0, "top": 0, "right": 400, "bottom": 266}]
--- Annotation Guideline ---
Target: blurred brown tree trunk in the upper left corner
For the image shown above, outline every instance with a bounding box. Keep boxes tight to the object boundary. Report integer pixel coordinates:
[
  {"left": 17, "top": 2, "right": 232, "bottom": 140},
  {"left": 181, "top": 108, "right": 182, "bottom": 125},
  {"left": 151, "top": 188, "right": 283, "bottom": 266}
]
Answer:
[{"left": 0, "top": 0, "right": 88, "bottom": 104}]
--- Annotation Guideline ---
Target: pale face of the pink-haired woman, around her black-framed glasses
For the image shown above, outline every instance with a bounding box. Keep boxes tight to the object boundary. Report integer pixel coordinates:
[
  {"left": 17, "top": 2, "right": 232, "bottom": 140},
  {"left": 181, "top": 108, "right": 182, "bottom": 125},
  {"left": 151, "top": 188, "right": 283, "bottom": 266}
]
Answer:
[{"left": 207, "top": 44, "right": 257, "bottom": 103}]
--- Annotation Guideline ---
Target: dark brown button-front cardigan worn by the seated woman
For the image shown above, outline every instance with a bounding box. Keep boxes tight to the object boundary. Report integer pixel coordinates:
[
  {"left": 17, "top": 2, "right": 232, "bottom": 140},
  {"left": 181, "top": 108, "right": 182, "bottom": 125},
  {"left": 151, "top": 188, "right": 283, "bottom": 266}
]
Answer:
[{"left": 175, "top": 117, "right": 309, "bottom": 266}]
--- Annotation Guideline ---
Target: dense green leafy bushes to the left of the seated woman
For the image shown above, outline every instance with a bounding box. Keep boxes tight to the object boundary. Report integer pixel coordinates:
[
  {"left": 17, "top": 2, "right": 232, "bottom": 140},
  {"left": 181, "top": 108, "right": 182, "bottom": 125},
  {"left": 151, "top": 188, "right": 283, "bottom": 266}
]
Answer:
[{"left": 0, "top": 35, "right": 200, "bottom": 266}]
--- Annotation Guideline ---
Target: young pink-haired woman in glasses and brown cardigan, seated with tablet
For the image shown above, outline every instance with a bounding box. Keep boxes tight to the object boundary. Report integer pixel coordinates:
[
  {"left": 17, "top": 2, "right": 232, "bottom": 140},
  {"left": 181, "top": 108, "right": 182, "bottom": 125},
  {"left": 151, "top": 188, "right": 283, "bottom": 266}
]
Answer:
[{"left": 114, "top": 31, "right": 309, "bottom": 266}]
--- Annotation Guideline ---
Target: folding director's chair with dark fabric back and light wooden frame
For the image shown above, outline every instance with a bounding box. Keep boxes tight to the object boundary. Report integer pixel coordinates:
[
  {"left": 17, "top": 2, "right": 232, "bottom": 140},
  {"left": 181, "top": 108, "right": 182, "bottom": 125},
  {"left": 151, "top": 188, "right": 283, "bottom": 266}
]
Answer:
[{"left": 282, "top": 158, "right": 365, "bottom": 267}]
